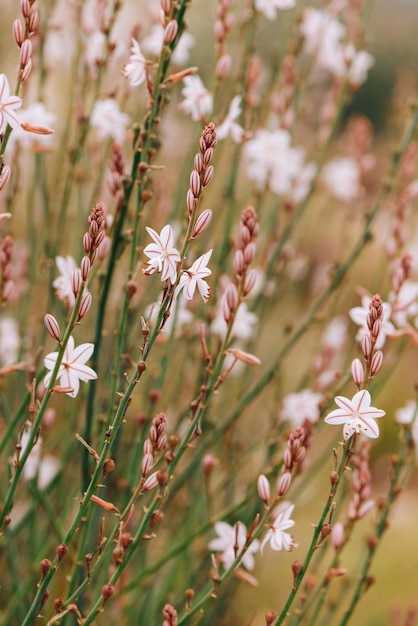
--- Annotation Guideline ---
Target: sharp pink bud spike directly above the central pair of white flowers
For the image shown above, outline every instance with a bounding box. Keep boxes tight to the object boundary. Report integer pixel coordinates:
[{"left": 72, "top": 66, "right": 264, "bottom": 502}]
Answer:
[{"left": 186, "top": 122, "right": 216, "bottom": 221}]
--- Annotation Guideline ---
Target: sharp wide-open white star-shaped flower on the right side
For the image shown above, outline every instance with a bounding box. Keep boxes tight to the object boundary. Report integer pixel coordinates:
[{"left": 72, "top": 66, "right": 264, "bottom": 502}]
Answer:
[{"left": 325, "top": 389, "right": 386, "bottom": 440}]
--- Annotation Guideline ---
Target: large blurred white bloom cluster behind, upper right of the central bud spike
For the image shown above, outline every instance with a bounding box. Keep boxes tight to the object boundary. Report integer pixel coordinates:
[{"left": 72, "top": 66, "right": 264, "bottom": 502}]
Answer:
[{"left": 244, "top": 129, "right": 304, "bottom": 195}]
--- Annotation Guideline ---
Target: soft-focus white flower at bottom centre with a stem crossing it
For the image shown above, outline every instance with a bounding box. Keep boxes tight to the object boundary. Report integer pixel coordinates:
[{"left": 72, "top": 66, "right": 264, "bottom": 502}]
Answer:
[{"left": 209, "top": 522, "right": 260, "bottom": 570}]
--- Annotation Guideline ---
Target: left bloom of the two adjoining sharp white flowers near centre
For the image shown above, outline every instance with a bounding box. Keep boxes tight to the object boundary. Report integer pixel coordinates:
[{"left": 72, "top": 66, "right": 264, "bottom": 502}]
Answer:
[{"left": 143, "top": 225, "right": 181, "bottom": 285}]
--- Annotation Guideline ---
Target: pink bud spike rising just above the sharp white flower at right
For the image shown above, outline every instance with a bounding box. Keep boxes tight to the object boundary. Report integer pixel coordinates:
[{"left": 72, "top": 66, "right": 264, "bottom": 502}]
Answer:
[{"left": 351, "top": 294, "right": 383, "bottom": 389}]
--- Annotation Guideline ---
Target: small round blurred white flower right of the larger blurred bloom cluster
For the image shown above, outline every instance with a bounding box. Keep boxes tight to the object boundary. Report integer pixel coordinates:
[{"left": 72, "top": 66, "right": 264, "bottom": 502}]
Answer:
[{"left": 322, "top": 157, "right": 360, "bottom": 202}]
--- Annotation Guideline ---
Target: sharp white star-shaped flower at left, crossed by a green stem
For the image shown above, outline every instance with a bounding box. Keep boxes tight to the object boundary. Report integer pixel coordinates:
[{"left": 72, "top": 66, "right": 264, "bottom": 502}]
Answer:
[{"left": 44, "top": 336, "right": 97, "bottom": 398}]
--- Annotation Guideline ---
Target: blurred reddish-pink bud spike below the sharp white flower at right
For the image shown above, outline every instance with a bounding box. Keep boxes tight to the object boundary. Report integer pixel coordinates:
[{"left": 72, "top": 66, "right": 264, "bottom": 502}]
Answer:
[{"left": 348, "top": 439, "right": 374, "bottom": 522}]
